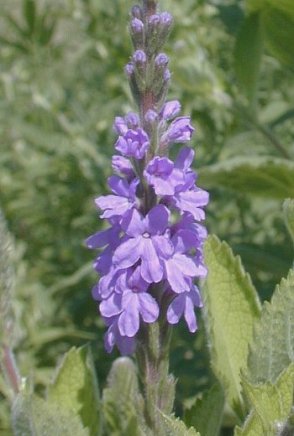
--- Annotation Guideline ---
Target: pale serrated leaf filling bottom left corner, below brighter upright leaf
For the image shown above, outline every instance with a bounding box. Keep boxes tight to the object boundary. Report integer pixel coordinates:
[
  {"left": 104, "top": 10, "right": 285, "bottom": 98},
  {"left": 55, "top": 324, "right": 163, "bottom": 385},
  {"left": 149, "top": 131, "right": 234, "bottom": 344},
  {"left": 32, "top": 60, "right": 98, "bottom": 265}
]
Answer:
[{"left": 12, "top": 393, "right": 90, "bottom": 436}]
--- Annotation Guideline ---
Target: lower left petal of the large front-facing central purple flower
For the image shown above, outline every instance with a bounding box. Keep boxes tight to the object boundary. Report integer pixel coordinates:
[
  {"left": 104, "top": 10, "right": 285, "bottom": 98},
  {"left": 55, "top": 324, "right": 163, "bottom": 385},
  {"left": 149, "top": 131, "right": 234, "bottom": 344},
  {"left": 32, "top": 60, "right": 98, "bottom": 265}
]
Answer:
[{"left": 113, "top": 236, "right": 142, "bottom": 268}]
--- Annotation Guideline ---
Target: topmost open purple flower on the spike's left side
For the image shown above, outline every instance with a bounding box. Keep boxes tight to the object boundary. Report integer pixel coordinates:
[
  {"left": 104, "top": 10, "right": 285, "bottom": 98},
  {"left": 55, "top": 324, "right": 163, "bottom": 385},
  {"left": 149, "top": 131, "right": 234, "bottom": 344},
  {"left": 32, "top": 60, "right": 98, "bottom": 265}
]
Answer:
[{"left": 115, "top": 128, "right": 150, "bottom": 159}]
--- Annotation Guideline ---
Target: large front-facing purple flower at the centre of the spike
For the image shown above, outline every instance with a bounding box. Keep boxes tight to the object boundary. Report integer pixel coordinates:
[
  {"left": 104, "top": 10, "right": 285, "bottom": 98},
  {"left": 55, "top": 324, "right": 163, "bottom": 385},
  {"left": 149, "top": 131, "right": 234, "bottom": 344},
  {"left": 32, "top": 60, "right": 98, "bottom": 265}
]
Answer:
[{"left": 113, "top": 205, "right": 173, "bottom": 283}]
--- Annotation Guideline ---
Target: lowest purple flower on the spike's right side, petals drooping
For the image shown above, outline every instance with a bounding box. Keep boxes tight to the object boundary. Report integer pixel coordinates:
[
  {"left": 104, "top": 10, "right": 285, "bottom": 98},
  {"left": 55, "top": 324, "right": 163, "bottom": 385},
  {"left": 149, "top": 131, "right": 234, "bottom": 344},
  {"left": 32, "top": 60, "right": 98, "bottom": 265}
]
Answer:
[{"left": 167, "top": 285, "right": 202, "bottom": 333}]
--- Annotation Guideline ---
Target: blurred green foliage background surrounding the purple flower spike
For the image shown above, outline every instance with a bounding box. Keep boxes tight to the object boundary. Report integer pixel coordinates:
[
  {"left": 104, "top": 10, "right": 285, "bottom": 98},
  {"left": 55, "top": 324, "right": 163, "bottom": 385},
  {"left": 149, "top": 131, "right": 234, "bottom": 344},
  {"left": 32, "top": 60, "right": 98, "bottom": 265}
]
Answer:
[{"left": 0, "top": 0, "right": 294, "bottom": 435}]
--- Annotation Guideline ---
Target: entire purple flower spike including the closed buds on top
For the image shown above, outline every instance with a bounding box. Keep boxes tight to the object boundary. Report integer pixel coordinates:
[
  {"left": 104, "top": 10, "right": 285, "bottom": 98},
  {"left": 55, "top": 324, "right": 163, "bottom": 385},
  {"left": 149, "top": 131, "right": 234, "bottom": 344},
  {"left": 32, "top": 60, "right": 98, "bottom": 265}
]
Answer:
[{"left": 87, "top": 0, "right": 208, "bottom": 354}]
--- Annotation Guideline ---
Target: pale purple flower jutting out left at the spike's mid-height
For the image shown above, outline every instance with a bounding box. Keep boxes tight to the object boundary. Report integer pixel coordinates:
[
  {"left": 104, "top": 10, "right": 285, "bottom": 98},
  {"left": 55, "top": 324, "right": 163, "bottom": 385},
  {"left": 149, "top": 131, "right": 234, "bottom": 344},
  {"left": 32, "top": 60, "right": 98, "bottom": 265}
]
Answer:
[{"left": 95, "top": 176, "right": 139, "bottom": 218}]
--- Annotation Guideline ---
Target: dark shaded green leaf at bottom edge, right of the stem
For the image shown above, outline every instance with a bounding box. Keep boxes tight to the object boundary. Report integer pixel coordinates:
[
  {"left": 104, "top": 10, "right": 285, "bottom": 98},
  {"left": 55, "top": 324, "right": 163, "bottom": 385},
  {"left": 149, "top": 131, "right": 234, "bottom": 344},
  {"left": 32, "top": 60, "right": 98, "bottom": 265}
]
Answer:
[{"left": 184, "top": 383, "right": 225, "bottom": 436}]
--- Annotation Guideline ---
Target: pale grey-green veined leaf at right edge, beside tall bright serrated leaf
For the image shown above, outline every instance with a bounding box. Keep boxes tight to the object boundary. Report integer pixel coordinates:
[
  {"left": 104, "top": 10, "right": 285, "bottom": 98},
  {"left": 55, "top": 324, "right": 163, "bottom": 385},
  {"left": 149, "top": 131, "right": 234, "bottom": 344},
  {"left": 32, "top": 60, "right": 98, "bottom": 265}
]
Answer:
[{"left": 248, "top": 270, "right": 294, "bottom": 383}]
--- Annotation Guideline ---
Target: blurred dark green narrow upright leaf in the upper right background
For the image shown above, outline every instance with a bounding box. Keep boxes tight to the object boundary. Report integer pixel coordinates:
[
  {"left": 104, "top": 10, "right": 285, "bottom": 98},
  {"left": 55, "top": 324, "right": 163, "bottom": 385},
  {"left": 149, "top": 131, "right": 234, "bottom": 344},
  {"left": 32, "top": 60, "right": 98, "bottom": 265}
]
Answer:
[{"left": 234, "top": 13, "right": 263, "bottom": 104}]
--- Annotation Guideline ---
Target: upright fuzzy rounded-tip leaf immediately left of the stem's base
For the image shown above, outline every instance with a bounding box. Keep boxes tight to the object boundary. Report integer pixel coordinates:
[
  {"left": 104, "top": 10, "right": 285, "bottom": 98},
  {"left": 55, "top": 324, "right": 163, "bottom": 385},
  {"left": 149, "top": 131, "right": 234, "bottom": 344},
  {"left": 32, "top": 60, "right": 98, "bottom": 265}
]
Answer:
[{"left": 103, "top": 357, "right": 148, "bottom": 436}]
